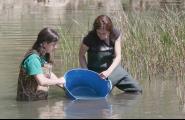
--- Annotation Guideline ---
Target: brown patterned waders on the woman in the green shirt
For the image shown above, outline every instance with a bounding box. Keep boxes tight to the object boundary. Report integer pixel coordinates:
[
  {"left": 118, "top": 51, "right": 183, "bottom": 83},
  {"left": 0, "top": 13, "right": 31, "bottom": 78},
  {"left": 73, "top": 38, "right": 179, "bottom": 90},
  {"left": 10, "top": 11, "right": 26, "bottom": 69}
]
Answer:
[{"left": 16, "top": 51, "right": 49, "bottom": 101}]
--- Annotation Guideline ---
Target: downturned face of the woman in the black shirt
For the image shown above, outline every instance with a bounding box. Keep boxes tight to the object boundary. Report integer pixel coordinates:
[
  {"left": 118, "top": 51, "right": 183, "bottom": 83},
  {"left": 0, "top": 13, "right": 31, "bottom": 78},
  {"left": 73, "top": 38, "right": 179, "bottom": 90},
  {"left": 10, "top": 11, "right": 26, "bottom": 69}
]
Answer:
[{"left": 96, "top": 28, "right": 110, "bottom": 40}]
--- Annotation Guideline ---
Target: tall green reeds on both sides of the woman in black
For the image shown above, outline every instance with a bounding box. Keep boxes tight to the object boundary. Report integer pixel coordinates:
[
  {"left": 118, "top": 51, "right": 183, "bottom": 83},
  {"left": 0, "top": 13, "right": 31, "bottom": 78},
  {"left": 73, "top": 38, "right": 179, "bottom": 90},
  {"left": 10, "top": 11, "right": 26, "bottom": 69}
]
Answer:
[{"left": 57, "top": 9, "right": 185, "bottom": 80}]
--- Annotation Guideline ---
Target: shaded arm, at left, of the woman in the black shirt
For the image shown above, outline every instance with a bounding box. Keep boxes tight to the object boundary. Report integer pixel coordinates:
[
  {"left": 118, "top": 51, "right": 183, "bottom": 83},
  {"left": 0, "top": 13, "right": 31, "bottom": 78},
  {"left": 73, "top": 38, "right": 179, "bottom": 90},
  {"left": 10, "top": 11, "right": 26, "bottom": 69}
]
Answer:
[{"left": 79, "top": 43, "right": 89, "bottom": 68}]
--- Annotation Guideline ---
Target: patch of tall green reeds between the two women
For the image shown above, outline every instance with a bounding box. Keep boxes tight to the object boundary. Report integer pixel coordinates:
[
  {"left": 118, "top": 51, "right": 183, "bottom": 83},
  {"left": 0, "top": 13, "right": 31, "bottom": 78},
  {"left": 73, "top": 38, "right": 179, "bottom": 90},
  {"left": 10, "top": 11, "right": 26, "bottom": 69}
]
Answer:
[{"left": 58, "top": 16, "right": 89, "bottom": 71}]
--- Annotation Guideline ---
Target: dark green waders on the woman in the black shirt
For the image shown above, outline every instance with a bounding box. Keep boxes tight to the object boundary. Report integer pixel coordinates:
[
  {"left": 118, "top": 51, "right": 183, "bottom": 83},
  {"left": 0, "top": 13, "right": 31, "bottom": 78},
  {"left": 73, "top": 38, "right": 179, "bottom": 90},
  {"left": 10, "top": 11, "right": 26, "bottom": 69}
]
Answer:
[{"left": 88, "top": 50, "right": 142, "bottom": 92}]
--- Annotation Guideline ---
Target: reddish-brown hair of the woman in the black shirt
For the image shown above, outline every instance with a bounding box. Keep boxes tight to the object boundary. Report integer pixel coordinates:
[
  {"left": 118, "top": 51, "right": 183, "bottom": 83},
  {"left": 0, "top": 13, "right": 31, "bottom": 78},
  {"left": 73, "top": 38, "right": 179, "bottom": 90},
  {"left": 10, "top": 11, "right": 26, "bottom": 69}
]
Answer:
[{"left": 93, "top": 15, "right": 113, "bottom": 32}]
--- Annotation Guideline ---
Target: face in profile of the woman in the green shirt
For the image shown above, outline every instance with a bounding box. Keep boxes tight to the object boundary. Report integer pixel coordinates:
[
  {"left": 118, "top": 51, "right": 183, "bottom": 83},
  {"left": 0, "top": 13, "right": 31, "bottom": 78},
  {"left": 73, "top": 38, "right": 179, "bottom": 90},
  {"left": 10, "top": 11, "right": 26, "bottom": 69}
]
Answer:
[{"left": 44, "top": 42, "right": 57, "bottom": 53}]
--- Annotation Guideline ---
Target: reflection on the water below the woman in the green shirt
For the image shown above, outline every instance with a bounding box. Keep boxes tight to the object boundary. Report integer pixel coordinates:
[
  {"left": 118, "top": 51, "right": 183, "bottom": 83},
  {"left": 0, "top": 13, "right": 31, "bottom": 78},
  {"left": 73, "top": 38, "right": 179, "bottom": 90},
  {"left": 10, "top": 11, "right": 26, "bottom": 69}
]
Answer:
[{"left": 16, "top": 100, "right": 65, "bottom": 119}]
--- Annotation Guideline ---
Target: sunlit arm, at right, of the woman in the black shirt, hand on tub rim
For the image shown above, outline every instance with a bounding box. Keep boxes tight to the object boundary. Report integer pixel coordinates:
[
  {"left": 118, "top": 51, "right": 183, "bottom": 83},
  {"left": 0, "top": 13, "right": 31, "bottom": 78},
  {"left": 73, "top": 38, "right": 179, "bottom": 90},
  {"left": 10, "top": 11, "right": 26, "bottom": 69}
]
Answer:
[{"left": 100, "top": 35, "right": 121, "bottom": 79}]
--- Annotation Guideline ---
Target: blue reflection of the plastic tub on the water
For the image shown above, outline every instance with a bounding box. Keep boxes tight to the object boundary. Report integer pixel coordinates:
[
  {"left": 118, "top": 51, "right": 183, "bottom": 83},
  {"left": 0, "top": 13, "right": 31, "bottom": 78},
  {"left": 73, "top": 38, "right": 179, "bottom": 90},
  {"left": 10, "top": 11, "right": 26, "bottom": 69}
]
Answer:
[{"left": 64, "top": 99, "right": 112, "bottom": 119}]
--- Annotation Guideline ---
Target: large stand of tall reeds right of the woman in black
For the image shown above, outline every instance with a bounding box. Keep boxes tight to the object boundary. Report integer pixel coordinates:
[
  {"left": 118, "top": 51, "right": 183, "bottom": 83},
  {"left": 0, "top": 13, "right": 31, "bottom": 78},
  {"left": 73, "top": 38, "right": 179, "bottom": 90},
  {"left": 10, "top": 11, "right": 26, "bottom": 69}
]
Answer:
[{"left": 111, "top": 9, "right": 185, "bottom": 104}]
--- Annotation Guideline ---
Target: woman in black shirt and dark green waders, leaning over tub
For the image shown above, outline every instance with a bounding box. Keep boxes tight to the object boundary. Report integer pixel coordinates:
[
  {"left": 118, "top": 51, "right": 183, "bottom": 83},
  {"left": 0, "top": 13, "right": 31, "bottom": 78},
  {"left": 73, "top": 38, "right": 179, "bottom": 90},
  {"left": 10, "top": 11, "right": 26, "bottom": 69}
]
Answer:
[{"left": 79, "top": 15, "right": 141, "bottom": 92}]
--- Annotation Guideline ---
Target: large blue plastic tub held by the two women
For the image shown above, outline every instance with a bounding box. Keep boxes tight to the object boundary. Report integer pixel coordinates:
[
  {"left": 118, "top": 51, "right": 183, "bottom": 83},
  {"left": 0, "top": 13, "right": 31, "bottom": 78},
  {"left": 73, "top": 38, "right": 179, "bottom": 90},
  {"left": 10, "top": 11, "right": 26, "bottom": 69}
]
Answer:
[{"left": 64, "top": 68, "right": 112, "bottom": 99}]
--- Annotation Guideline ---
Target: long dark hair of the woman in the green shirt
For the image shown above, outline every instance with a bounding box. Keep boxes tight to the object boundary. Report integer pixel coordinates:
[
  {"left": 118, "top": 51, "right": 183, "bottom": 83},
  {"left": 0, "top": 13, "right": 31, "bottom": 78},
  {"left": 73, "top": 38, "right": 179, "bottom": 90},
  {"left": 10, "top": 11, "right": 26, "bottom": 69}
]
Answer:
[{"left": 32, "top": 28, "right": 59, "bottom": 63}]
